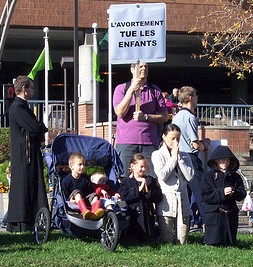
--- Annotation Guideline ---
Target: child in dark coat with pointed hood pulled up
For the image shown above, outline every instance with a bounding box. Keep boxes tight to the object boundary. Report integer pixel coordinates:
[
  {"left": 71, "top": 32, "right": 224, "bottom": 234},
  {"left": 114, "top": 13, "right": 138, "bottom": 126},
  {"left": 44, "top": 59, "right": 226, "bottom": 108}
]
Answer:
[{"left": 201, "top": 146, "right": 246, "bottom": 246}]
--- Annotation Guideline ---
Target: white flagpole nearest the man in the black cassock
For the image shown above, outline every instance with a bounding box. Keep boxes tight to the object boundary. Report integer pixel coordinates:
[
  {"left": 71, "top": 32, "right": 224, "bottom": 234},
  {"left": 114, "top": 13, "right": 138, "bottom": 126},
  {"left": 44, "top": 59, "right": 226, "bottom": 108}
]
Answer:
[{"left": 43, "top": 27, "right": 49, "bottom": 145}]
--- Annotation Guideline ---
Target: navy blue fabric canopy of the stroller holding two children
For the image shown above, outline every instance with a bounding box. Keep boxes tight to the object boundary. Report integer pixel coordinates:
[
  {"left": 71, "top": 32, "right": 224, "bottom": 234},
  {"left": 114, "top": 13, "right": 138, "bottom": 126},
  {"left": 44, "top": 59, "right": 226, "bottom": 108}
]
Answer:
[{"left": 51, "top": 134, "right": 123, "bottom": 184}]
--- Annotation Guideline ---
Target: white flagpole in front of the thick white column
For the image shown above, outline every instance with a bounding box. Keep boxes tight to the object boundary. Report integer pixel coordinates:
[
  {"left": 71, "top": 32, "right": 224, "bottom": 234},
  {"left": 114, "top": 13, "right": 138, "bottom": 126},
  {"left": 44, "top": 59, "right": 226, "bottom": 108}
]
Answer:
[{"left": 92, "top": 23, "right": 98, "bottom": 136}]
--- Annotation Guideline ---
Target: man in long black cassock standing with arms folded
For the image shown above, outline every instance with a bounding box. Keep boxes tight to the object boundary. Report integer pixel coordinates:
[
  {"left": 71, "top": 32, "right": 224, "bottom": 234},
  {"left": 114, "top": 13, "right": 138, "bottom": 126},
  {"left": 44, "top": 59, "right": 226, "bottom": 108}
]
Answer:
[{"left": 7, "top": 76, "right": 48, "bottom": 232}]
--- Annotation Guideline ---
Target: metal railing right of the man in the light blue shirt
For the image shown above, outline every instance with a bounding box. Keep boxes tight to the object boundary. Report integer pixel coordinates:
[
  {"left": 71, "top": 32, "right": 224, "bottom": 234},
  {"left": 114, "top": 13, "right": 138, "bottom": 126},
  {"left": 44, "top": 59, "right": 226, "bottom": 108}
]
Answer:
[{"left": 197, "top": 104, "right": 253, "bottom": 126}]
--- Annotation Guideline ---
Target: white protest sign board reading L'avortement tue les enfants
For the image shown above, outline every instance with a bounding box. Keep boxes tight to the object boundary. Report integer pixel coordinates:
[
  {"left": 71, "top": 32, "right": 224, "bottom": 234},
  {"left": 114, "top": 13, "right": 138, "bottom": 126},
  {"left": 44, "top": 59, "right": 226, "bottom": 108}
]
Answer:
[{"left": 109, "top": 3, "right": 166, "bottom": 64}]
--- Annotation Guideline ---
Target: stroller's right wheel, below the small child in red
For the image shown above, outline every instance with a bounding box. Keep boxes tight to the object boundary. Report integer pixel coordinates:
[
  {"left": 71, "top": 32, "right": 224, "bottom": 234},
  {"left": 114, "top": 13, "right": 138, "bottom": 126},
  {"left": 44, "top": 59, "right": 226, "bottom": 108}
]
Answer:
[{"left": 101, "top": 211, "right": 120, "bottom": 251}]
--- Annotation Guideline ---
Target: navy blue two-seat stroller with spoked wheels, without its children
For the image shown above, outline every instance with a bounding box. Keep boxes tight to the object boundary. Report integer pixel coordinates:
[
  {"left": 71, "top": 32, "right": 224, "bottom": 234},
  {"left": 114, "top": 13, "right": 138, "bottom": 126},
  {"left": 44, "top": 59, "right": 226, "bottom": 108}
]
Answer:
[{"left": 34, "top": 134, "right": 129, "bottom": 251}]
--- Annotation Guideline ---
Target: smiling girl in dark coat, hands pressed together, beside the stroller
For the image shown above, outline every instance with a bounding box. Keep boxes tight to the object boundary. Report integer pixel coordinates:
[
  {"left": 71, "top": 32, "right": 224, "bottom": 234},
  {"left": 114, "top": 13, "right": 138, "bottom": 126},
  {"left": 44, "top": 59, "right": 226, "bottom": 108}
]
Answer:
[{"left": 119, "top": 153, "right": 162, "bottom": 238}]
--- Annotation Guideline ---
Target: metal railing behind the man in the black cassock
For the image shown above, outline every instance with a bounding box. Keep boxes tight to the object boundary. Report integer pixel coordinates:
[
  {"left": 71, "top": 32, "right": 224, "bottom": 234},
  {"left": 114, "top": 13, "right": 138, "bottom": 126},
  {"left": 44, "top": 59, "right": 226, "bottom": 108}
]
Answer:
[{"left": 0, "top": 100, "right": 73, "bottom": 131}]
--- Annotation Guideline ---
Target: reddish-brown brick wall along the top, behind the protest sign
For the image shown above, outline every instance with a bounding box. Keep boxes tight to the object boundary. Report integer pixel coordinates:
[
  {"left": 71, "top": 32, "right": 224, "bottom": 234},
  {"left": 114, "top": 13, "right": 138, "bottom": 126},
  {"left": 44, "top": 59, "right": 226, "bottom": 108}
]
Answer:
[{"left": 3, "top": 0, "right": 221, "bottom": 32}]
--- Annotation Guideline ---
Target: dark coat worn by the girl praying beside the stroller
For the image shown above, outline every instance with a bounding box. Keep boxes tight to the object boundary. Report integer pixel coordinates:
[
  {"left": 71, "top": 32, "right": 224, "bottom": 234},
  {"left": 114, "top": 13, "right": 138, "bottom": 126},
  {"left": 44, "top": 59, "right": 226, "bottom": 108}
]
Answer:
[{"left": 119, "top": 176, "right": 162, "bottom": 238}]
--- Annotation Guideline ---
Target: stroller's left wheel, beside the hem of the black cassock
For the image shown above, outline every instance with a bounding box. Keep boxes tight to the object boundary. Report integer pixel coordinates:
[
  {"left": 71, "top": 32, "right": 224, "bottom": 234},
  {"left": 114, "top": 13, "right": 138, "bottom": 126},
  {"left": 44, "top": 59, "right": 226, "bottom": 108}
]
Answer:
[{"left": 34, "top": 208, "right": 50, "bottom": 244}]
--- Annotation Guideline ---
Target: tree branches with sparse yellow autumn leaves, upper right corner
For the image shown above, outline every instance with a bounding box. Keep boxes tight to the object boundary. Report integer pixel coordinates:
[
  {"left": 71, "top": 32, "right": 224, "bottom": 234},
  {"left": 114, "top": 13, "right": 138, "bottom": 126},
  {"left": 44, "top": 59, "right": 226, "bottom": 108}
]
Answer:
[{"left": 191, "top": 0, "right": 253, "bottom": 79}]
